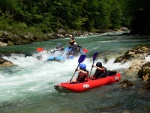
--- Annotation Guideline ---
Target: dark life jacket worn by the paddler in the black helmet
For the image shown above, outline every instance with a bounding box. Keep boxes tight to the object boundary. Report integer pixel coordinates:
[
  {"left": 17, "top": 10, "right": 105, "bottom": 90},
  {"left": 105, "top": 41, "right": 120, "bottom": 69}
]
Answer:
[{"left": 93, "top": 67, "right": 107, "bottom": 79}]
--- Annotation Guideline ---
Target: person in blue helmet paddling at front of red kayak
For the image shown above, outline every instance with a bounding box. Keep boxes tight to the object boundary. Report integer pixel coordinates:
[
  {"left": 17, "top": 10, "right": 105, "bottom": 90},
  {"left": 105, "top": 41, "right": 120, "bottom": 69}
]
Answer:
[{"left": 73, "top": 63, "right": 89, "bottom": 83}]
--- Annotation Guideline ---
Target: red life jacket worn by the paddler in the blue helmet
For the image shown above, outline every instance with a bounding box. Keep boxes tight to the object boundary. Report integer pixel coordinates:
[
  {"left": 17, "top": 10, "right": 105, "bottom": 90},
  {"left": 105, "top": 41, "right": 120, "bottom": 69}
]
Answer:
[{"left": 77, "top": 70, "right": 88, "bottom": 83}]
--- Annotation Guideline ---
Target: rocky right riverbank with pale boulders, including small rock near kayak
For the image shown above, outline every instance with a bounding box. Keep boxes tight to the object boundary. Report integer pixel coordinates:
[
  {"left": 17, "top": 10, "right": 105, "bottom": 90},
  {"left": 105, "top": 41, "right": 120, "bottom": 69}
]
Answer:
[{"left": 115, "top": 46, "right": 150, "bottom": 90}]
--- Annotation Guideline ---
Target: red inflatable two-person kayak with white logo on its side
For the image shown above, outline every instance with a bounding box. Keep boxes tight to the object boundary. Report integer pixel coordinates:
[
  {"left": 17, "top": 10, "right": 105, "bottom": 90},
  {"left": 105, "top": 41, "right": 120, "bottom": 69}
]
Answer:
[{"left": 54, "top": 73, "right": 121, "bottom": 93}]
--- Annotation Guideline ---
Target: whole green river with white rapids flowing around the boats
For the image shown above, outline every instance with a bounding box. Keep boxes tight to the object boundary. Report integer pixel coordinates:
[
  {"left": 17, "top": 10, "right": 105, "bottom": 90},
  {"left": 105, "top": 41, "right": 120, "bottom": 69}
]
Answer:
[{"left": 0, "top": 33, "right": 150, "bottom": 113}]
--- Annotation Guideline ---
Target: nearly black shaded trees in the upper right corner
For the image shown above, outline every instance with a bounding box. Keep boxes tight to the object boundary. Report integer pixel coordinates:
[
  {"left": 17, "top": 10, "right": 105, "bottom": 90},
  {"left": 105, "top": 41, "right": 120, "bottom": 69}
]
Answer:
[{"left": 130, "top": 0, "right": 150, "bottom": 35}]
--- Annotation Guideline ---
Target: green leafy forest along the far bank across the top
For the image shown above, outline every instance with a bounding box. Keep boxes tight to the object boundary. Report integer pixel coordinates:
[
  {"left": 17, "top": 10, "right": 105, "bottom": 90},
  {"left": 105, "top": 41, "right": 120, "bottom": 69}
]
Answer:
[{"left": 0, "top": 0, "right": 150, "bottom": 34}]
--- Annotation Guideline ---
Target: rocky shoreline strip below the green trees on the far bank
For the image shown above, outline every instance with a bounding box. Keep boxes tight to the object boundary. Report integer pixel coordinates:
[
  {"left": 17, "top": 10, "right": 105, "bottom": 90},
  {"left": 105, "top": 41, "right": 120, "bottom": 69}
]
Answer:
[{"left": 0, "top": 27, "right": 129, "bottom": 46}]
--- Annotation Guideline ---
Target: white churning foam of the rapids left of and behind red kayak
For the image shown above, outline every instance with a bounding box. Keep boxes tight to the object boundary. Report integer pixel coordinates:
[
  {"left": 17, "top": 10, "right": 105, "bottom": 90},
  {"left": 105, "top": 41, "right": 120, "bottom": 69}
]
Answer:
[{"left": 0, "top": 54, "right": 129, "bottom": 101}]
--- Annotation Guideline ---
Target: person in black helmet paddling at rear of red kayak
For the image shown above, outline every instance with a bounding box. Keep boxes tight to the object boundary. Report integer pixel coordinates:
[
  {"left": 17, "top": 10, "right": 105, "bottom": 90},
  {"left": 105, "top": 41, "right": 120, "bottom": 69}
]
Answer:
[{"left": 90, "top": 62, "right": 107, "bottom": 80}]
